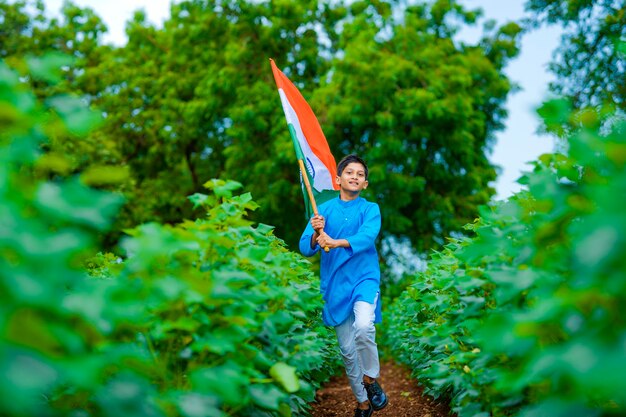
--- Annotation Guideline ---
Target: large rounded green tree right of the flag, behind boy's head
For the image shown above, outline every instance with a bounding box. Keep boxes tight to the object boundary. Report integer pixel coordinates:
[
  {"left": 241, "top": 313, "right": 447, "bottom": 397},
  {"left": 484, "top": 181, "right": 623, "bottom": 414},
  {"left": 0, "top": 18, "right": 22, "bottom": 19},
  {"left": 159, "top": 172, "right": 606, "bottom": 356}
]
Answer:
[{"left": 308, "top": 1, "right": 520, "bottom": 251}]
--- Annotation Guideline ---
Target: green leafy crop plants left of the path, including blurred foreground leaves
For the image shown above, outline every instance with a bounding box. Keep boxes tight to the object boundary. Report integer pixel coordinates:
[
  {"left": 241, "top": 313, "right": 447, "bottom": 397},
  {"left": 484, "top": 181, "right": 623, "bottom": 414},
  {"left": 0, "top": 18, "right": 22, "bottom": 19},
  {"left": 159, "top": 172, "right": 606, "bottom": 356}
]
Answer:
[{"left": 0, "top": 56, "right": 337, "bottom": 417}]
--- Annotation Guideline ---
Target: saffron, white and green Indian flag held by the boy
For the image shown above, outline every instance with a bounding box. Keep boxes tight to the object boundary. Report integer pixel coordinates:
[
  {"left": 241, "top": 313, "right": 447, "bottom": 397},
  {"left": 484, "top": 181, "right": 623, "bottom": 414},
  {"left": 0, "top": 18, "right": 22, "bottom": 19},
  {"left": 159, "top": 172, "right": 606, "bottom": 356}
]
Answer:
[{"left": 270, "top": 59, "right": 339, "bottom": 217}]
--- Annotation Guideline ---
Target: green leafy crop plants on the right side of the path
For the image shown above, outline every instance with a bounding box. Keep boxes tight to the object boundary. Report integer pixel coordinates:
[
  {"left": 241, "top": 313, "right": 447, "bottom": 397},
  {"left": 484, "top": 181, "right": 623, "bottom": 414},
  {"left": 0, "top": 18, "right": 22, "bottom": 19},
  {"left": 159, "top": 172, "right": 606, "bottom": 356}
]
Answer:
[{"left": 386, "top": 102, "right": 626, "bottom": 416}]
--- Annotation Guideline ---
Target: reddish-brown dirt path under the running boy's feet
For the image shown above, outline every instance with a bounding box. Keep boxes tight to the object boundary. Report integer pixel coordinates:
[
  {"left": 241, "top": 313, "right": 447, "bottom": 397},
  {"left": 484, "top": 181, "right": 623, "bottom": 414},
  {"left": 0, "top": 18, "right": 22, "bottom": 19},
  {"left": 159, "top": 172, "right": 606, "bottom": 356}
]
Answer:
[{"left": 311, "top": 362, "right": 450, "bottom": 417}]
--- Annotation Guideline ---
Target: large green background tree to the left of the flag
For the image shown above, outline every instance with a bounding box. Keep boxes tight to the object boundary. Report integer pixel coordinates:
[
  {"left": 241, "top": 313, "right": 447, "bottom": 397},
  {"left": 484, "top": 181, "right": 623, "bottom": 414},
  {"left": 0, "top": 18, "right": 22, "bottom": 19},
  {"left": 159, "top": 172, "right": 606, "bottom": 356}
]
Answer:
[{"left": 80, "top": 1, "right": 344, "bottom": 234}]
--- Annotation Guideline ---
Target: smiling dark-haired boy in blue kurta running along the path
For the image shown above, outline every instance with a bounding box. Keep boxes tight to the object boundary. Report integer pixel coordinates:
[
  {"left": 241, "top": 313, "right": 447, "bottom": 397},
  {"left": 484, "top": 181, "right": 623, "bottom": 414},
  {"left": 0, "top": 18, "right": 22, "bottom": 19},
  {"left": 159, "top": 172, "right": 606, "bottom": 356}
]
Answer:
[{"left": 300, "top": 155, "right": 388, "bottom": 417}]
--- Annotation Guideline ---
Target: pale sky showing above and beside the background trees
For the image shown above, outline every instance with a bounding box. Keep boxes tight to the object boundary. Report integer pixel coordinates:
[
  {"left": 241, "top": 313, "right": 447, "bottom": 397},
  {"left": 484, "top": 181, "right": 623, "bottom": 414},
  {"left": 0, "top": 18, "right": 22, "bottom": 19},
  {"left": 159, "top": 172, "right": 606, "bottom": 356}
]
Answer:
[{"left": 44, "top": 0, "right": 560, "bottom": 199}]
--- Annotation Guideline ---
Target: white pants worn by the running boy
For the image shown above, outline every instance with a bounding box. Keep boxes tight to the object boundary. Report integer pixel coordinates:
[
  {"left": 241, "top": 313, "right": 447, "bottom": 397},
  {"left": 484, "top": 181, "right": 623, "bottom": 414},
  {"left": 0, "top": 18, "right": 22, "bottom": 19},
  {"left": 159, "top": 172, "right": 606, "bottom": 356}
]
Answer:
[{"left": 335, "top": 297, "right": 380, "bottom": 403}]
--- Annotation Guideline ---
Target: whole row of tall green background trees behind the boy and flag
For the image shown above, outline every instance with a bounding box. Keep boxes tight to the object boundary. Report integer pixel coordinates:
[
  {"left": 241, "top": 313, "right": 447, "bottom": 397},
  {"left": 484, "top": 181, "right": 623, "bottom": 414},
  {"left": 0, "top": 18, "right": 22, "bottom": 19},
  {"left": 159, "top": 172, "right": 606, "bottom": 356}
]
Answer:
[{"left": 0, "top": 0, "right": 519, "bottom": 255}]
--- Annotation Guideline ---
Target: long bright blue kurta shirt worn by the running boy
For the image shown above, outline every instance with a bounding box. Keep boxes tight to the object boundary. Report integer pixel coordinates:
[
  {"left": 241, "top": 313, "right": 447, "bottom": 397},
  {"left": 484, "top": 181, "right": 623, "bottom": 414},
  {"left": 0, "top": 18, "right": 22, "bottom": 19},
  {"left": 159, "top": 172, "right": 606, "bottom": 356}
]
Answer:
[{"left": 300, "top": 197, "right": 382, "bottom": 326}]
